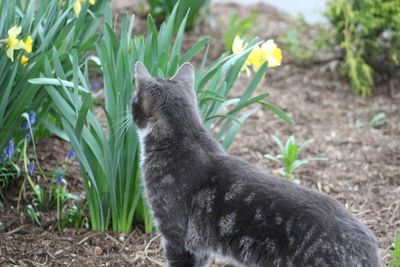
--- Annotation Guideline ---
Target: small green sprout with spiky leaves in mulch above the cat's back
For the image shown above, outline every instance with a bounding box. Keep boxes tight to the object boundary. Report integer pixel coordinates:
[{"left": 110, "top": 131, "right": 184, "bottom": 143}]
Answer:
[{"left": 264, "top": 135, "right": 327, "bottom": 183}]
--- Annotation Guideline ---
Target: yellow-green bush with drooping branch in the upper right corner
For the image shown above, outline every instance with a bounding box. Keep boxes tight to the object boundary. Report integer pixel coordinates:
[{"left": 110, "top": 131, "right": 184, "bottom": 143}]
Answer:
[{"left": 326, "top": 0, "right": 400, "bottom": 96}]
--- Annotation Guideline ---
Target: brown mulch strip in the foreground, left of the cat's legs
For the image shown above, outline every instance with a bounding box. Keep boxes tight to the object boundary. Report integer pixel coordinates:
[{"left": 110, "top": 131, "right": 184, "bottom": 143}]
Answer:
[{"left": 0, "top": 210, "right": 161, "bottom": 267}]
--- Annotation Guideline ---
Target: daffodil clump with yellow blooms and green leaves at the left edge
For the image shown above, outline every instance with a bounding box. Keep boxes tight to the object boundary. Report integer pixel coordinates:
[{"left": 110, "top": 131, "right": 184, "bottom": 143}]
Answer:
[{"left": 0, "top": 0, "right": 107, "bottom": 177}]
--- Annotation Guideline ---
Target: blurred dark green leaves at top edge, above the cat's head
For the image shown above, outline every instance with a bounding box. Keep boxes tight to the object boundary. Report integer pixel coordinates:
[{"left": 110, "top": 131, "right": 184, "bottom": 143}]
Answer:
[{"left": 147, "top": 0, "right": 211, "bottom": 33}]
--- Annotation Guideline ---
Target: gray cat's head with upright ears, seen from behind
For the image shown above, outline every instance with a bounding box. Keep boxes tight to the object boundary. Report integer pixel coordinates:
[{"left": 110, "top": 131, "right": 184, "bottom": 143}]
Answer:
[{"left": 132, "top": 62, "right": 198, "bottom": 129}]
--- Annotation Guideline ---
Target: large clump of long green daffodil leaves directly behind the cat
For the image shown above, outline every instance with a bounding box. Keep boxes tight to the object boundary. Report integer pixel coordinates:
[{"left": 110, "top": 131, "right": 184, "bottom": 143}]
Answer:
[{"left": 31, "top": 3, "right": 291, "bottom": 232}]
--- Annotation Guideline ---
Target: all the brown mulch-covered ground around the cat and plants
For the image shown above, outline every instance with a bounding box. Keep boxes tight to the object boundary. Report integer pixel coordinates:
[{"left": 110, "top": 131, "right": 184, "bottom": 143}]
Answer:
[{"left": 0, "top": 1, "right": 400, "bottom": 266}]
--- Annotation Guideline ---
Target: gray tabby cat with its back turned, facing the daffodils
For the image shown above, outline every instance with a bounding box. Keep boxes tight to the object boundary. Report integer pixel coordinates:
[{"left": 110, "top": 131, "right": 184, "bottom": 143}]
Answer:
[{"left": 132, "top": 62, "right": 380, "bottom": 267}]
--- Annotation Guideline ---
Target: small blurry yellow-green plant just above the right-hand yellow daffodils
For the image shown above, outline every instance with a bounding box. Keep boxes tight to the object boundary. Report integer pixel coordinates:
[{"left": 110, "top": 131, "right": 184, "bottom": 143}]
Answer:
[{"left": 222, "top": 12, "right": 258, "bottom": 51}]
